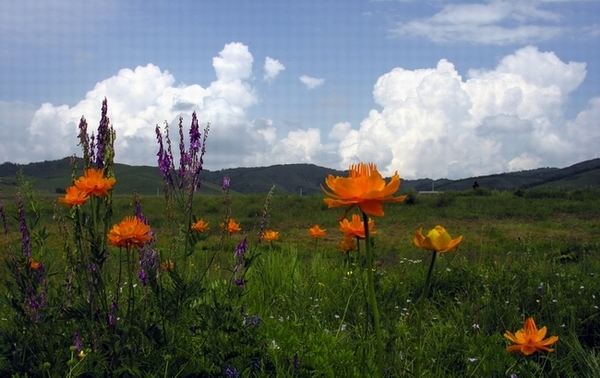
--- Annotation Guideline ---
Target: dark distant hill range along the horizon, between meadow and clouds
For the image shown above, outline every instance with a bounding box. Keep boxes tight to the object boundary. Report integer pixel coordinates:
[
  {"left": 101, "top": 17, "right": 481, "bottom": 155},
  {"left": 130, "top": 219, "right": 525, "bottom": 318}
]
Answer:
[{"left": 0, "top": 158, "right": 600, "bottom": 195}]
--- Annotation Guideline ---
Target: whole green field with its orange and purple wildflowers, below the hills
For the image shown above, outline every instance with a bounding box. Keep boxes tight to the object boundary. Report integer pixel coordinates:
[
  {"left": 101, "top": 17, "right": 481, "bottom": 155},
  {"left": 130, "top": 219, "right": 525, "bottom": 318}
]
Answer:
[{"left": 0, "top": 103, "right": 600, "bottom": 377}]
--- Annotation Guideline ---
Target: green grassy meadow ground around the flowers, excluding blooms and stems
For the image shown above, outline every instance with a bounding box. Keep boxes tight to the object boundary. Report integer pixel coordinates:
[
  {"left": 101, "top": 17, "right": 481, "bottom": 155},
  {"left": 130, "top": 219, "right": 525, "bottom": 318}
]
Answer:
[{"left": 0, "top": 182, "right": 600, "bottom": 377}]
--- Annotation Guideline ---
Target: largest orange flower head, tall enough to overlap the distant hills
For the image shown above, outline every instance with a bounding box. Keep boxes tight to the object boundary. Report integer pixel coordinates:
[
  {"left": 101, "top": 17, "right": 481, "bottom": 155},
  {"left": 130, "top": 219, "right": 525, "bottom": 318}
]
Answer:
[{"left": 321, "top": 163, "right": 406, "bottom": 217}]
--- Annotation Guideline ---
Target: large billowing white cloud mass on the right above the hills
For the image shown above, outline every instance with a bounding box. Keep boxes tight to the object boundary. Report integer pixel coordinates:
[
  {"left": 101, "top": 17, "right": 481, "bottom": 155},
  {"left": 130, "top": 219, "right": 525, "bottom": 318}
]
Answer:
[{"left": 330, "top": 46, "right": 600, "bottom": 178}]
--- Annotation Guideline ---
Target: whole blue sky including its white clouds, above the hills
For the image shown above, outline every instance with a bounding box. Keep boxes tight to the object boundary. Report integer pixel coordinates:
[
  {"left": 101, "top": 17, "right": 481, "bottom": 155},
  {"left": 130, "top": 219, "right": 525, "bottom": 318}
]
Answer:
[{"left": 0, "top": 0, "right": 600, "bottom": 179}]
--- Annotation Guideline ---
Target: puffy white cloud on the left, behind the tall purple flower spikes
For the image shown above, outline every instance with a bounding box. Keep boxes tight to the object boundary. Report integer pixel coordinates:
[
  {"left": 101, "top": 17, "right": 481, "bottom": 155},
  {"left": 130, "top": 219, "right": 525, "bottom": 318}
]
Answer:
[{"left": 9, "top": 43, "right": 264, "bottom": 168}]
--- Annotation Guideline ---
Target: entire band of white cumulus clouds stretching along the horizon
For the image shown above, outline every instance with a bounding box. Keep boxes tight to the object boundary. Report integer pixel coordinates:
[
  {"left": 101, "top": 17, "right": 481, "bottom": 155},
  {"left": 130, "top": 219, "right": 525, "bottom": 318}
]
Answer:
[{"left": 0, "top": 43, "right": 600, "bottom": 178}]
